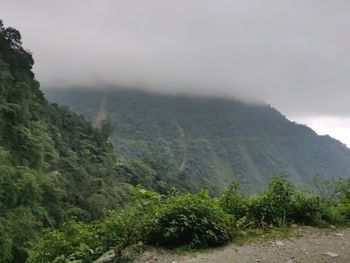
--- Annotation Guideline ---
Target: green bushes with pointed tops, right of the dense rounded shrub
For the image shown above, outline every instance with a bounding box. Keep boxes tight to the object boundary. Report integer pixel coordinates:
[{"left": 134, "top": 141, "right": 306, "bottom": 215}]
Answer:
[{"left": 220, "top": 175, "right": 347, "bottom": 228}]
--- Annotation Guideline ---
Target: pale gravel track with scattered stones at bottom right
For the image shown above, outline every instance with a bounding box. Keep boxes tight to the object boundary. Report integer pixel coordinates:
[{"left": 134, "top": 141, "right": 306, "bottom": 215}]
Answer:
[{"left": 135, "top": 227, "right": 350, "bottom": 263}]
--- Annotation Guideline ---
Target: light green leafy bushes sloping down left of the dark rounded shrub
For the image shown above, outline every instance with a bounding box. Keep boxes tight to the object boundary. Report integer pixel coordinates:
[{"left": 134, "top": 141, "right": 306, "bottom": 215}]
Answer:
[{"left": 28, "top": 187, "right": 163, "bottom": 263}]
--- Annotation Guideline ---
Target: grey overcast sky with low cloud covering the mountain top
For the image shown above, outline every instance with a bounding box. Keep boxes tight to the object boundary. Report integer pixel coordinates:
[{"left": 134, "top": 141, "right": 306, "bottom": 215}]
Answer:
[{"left": 0, "top": 0, "right": 350, "bottom": 145}]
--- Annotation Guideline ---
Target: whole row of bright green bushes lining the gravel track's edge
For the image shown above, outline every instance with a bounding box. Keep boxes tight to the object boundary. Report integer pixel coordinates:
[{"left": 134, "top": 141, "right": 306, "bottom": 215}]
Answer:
[{"left": 28, "top": 176, "right": 350, "bottom": 263}]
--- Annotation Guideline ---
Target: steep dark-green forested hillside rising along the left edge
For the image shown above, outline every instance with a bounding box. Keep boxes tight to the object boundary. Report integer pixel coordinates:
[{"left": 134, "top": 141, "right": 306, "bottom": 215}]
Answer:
[{"left": 0, "top": 20, "right": 138, "bottom": 262}]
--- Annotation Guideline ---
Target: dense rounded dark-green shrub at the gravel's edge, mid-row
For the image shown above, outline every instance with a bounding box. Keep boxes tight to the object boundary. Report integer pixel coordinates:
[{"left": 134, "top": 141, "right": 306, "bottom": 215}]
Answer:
[{"left": 150, "top": 191, "right": 231, "bottom": 248}]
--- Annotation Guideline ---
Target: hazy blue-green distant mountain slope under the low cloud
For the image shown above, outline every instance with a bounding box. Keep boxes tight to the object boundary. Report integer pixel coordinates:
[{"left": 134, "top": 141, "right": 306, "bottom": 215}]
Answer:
[{"left": 46, "top": 88, "right": 350, "bottom": 192}]
